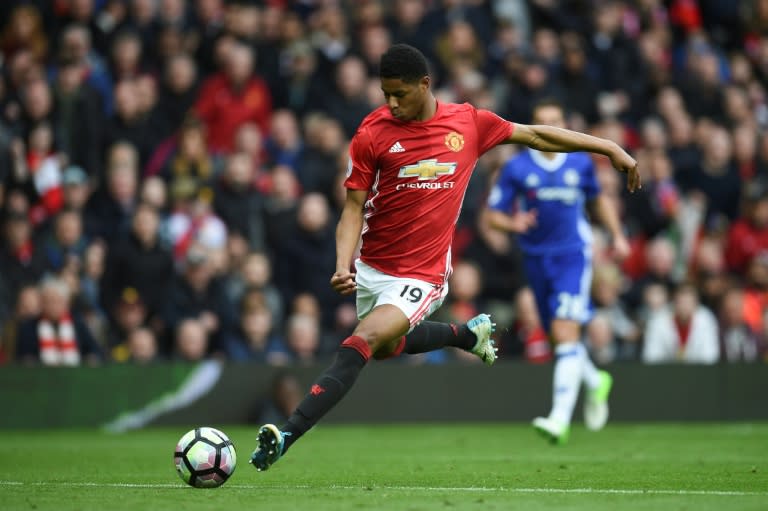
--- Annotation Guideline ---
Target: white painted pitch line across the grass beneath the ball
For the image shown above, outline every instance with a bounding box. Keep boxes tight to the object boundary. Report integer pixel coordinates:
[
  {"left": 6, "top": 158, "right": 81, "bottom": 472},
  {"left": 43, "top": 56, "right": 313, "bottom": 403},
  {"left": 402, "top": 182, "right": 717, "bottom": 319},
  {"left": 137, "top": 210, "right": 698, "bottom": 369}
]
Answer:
[{"left": 0, "top": 481, "right": 768, "bottom": 497}]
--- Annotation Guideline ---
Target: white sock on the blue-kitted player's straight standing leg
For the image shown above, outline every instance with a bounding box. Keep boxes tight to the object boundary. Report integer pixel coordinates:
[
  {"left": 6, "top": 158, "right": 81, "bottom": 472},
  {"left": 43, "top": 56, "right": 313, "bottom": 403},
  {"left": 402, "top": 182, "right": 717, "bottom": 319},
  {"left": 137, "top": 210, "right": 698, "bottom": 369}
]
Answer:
[{"left": 549, "top": 342, "right": 584, "bottom": 424}]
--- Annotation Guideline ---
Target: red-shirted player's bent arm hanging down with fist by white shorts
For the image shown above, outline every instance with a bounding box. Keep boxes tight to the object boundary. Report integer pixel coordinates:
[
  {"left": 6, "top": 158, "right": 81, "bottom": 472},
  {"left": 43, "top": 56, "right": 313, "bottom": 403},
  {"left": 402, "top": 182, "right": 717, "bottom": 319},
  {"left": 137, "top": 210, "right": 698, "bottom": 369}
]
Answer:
[{"left": 331, "top": 189, "right": 368, "bottom": 295}]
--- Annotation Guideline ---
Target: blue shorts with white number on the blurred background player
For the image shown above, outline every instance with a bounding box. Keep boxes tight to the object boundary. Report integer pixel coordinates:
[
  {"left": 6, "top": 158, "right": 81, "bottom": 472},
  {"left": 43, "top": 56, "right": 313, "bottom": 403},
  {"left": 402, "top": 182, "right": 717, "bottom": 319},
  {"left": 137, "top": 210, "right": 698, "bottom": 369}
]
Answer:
[{"left": 523, "top": 248, "right": 592, "bottom": 331}]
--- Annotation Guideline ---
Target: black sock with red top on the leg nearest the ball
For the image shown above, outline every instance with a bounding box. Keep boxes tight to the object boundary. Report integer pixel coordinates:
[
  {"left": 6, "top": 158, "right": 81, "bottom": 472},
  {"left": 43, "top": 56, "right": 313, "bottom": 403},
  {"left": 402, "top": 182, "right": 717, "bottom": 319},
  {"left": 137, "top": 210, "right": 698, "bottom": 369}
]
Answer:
[{"left": 280, "top": 337, "right": 370, "bottom": 452}]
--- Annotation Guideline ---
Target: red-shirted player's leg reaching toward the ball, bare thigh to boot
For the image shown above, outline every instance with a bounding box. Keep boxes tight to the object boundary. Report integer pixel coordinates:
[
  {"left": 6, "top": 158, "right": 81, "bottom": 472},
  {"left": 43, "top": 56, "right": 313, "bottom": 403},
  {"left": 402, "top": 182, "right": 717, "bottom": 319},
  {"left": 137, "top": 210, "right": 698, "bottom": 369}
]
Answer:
[{"left": 251, "top": 304, "right": 410, "bottom": 471}]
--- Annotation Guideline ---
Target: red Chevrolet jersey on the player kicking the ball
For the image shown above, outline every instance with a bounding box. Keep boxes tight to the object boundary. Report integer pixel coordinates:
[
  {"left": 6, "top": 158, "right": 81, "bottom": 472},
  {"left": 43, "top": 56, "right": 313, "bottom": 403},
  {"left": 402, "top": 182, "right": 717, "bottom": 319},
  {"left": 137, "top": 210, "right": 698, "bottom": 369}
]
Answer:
[{"left": 344, "top": 102, "right": 514, "bottom": 284}]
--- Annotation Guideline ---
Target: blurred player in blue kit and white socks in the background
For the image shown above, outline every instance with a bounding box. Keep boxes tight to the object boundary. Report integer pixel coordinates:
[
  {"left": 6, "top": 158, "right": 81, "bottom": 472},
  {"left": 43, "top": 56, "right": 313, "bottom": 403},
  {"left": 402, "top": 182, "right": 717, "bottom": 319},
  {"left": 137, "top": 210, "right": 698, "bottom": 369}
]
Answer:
[{"left": 486, "top": 100, "right": 629, "bottom": 444}]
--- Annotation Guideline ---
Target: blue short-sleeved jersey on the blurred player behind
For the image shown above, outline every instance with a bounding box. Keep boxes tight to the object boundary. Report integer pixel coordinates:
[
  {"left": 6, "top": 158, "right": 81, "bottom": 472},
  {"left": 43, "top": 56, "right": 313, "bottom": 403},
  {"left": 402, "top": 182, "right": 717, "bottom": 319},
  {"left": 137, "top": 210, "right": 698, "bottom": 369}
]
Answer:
[{"left": 488, "top": 149, "right": 600, "bottom": 255}]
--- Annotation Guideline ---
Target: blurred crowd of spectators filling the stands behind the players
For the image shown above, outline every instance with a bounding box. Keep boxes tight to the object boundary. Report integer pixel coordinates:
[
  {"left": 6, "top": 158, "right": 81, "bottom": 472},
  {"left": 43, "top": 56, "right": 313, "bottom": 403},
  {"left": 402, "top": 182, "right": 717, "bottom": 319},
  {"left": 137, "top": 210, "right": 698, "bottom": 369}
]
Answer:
[{"left": 0, "top": 0, "right": 768, "bottom": 365}]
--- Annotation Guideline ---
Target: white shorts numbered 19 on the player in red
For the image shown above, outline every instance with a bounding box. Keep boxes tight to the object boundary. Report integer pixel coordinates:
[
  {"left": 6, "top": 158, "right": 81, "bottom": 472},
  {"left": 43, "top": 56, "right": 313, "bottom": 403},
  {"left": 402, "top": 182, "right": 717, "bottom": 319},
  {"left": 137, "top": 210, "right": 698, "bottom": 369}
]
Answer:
[{"left": 355, "top": 259, "right": 448, "bottom": 329}]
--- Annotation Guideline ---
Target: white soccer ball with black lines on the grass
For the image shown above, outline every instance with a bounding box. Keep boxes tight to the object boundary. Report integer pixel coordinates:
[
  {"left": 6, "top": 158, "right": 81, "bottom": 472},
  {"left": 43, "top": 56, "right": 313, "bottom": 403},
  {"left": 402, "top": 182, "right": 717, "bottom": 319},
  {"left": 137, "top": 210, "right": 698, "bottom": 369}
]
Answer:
[{"left": 173, "top": 427, "right": 237, "bottom": 488}]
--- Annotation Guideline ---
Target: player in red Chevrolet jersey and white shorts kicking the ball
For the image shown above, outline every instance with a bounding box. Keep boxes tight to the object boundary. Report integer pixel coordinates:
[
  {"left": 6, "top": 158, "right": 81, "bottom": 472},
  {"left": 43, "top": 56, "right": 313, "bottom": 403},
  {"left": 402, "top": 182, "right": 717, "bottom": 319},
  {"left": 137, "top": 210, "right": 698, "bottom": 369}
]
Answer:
[{"left": 251, "top": 44, "right": 639, "bottom": 470}]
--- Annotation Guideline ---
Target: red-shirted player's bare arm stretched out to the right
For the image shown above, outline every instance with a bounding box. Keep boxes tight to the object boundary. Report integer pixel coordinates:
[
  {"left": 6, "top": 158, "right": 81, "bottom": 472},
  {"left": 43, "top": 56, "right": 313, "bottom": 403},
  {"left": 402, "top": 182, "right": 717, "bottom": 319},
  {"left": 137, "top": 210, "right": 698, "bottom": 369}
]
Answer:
[{"left": 505, "top": 123, "right": 640, "bottom": 192}]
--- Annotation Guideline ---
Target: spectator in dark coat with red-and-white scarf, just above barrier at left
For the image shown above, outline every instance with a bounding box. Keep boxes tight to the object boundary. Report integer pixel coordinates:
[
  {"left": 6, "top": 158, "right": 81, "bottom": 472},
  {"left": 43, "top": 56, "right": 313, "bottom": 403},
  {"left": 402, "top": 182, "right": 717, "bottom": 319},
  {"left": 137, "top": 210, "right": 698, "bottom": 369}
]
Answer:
[{"left": 16, "top": 277, "right": 101, "bottom": 366}]
